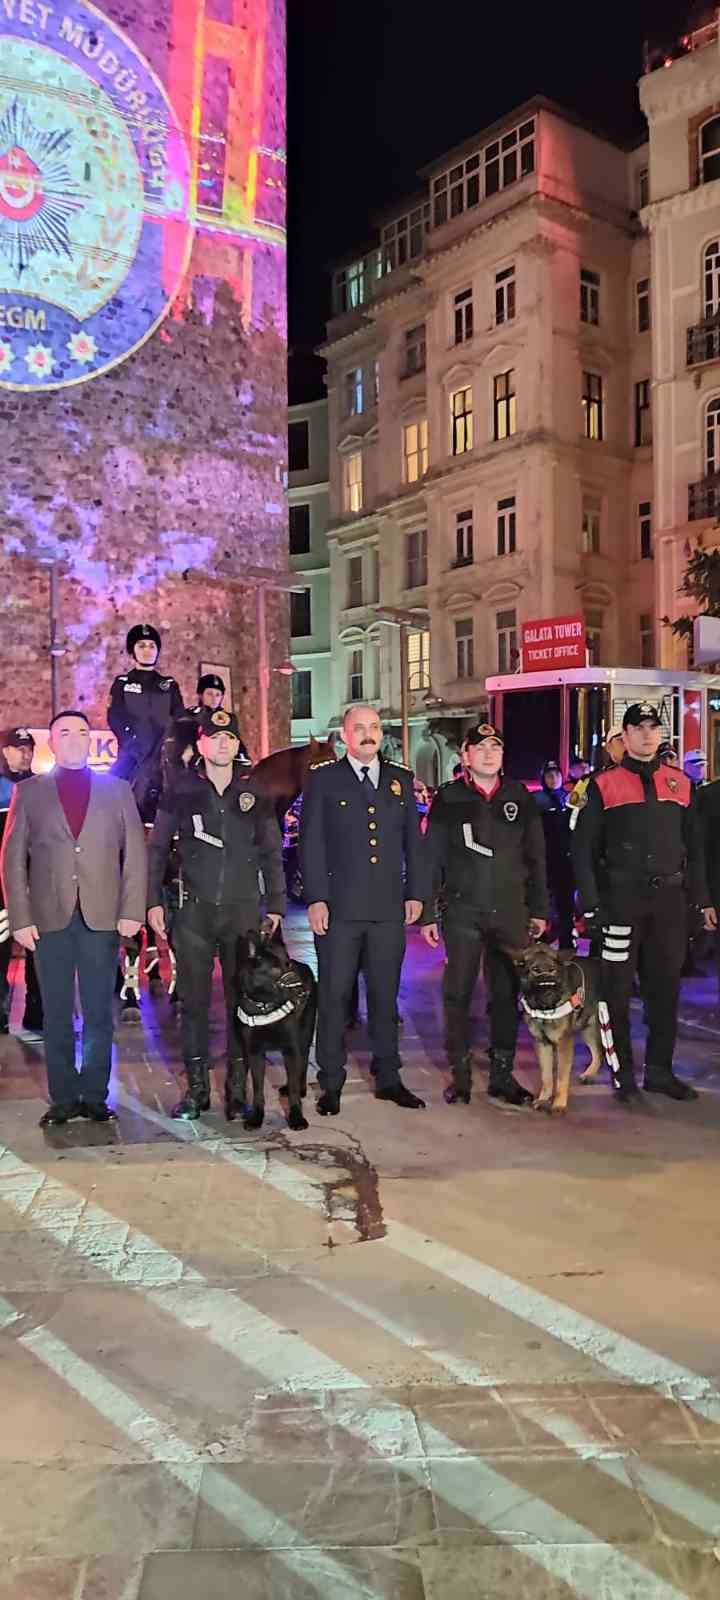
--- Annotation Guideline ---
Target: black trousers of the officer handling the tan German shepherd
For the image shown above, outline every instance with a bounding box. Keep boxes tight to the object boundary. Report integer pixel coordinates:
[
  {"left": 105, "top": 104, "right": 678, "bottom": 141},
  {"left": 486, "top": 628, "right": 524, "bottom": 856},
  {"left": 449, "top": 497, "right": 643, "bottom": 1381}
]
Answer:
[{"left": 443, "top": 907, "right": 528, "bottom": 1067}]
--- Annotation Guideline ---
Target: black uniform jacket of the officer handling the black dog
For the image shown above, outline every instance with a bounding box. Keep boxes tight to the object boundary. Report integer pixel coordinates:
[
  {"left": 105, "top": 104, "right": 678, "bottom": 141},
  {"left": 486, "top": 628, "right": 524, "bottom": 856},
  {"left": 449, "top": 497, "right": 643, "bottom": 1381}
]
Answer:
[{"left": 147, "top": 765, "right": 286, "bottom": 917}]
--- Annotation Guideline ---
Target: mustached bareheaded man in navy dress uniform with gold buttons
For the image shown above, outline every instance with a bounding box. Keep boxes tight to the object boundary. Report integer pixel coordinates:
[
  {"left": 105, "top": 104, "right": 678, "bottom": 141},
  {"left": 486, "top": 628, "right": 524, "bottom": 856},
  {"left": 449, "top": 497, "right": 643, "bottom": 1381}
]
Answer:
[{"left": 299, "top": 706, "right": 424, "bottom": 1117}]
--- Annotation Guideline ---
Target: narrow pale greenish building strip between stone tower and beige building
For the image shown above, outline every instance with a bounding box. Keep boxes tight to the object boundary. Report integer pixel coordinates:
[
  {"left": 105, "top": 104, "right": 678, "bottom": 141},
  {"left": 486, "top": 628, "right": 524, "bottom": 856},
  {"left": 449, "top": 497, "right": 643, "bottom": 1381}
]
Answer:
[{"left": 288, "top": 400, "right": 334, "bottom": 744}]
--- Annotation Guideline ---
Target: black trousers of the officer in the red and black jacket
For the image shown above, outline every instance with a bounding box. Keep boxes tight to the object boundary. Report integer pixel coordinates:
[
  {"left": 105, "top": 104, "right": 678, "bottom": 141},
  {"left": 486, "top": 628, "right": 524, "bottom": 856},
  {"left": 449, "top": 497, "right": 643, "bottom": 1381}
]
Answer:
[{"left": 600, "top": 885, "right": 686, "bottom": 1074}]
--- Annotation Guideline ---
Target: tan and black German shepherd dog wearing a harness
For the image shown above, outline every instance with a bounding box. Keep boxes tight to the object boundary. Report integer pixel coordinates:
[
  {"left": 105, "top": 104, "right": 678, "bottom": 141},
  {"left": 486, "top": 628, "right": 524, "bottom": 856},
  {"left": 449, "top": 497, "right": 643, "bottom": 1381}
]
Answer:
[{"left": 509, "top": 944, "right": 603, "bottom": 1115}]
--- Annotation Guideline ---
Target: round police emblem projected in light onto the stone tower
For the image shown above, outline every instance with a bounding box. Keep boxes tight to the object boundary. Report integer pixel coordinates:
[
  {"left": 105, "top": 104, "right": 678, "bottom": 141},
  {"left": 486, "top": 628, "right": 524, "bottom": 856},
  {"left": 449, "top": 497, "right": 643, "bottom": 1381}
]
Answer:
[{"left": 0, "top": 0, "right": 192, "bottom": 390}]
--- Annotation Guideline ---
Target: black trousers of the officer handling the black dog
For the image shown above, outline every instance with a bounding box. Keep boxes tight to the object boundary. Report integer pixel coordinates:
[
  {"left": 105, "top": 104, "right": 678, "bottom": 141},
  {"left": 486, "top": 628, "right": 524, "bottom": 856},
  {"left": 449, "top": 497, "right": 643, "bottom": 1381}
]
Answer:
[{"left": 173, "top": 899, "right": 259, "bottom": 1066}]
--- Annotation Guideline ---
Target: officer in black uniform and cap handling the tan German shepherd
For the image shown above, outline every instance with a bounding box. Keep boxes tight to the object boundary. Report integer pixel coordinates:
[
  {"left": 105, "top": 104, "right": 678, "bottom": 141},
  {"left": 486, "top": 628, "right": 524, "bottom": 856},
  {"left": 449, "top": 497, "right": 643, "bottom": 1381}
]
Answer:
[{"left": 422, "top": 723, "right": 547, "bottom": 1106}]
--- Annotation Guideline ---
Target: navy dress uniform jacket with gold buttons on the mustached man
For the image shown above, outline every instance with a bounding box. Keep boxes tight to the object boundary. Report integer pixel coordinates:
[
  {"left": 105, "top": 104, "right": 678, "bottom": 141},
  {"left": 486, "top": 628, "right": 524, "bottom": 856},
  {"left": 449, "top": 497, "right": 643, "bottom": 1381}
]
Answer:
[{"left": 299, "top": 757, "right": 424, "bottom": 922}]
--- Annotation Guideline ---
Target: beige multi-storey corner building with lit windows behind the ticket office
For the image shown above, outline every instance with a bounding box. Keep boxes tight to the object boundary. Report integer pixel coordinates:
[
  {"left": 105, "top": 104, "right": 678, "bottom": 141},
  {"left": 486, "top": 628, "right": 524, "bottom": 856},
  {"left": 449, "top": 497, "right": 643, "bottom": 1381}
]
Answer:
[{"left": 323, "top": 99, "right": 658, "bottom": 781}]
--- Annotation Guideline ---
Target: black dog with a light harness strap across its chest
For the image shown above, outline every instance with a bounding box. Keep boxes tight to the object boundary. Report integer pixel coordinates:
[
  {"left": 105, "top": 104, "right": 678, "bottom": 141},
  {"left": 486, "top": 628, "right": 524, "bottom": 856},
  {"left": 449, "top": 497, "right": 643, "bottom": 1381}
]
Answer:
[{"left": 226, "top": 933, "right": 317, "bottom": 1130}]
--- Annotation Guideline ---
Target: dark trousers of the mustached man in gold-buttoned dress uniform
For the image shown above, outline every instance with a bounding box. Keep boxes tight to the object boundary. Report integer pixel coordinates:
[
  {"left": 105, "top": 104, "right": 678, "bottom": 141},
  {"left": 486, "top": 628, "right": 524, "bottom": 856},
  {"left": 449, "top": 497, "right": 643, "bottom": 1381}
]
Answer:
[{"left": 315, "top": 917, "right": 405, "bottom": 1093}]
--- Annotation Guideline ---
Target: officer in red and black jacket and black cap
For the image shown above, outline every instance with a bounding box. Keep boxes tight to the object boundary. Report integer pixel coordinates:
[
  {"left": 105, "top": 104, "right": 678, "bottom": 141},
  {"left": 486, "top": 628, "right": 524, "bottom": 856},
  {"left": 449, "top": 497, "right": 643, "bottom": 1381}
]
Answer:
[{"left": 571, "top": 704, "right": 717, "bottom": 1101}]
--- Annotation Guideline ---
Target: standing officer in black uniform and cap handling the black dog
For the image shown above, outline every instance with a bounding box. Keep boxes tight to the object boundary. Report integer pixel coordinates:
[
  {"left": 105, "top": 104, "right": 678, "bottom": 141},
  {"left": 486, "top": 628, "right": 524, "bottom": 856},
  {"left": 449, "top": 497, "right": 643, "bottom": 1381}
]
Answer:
[{"left": 147, "top": 710, "right": 285, "bottom": 1120}]
